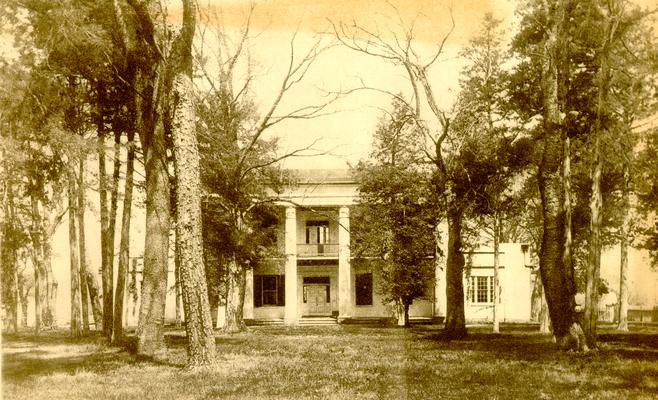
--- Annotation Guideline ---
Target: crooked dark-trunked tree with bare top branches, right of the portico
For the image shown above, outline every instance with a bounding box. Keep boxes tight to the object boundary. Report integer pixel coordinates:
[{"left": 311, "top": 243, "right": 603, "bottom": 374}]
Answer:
[{"left": 333, "top": 5, "right": 468, "bottom": 338}]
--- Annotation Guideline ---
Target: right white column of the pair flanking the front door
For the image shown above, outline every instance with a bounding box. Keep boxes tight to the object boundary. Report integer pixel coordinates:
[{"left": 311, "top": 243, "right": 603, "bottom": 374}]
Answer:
[{"left": 338, "top": 207, "right": 354, "bottom": 321}]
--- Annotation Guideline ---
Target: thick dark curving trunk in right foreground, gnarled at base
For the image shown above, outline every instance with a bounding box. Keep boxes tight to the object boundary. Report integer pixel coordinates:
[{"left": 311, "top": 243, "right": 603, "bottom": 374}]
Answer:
[{"left": 538, "top": 0, "right": 586, "bottom": 349}]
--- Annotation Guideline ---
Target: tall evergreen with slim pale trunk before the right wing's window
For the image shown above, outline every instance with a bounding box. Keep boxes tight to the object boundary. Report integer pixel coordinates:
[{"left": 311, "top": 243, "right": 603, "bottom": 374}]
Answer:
[{"left": 452, "top": 14, "right": 532, "bottom": 332}]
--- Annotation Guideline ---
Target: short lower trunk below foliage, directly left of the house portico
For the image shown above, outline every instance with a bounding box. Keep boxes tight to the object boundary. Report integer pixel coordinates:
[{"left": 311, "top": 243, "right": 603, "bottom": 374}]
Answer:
[{"left": 224, "top": 254, "right": 247, "bottom": 333}]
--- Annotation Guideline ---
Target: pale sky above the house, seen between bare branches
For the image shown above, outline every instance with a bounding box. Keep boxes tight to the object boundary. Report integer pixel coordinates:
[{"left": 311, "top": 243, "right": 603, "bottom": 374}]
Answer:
[{"left": 187, "top": 0, "right": 514, "bottom": 168}]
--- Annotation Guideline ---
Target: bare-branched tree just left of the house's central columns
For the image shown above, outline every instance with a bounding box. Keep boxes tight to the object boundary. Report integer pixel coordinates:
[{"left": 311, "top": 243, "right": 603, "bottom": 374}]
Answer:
[{"left": 197, "top": 5, "right": 346, "bottom": 332}]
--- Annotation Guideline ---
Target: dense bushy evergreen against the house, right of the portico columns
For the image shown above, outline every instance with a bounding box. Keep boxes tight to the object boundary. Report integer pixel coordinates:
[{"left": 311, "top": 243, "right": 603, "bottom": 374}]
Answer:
[{"left": 352, "top": 101, "right": 437, "bottom": 327}]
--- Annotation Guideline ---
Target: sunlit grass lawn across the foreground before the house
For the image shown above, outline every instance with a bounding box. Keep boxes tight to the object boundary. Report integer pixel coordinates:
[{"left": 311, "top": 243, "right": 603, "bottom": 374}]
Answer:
[{"left": 2, "top": 326, "right": 658, "bottom": 400}]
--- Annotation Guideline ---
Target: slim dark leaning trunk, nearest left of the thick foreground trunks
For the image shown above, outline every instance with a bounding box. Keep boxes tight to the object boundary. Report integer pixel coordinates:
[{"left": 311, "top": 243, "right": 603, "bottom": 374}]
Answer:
[{"left": 112, "top": 130, "right": 135, "bottom": 343}]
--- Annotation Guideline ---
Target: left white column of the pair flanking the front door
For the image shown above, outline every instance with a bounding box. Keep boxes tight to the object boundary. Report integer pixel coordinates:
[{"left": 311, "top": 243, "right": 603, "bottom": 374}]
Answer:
[{"left": 283, "top": 207, "right": 297, "bottom": 325}]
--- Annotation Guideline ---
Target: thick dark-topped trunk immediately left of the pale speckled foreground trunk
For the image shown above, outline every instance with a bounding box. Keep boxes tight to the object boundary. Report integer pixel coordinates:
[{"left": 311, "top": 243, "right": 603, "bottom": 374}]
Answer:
[{"left": 112, "top": 1, "right": 171, "bottom": 358}]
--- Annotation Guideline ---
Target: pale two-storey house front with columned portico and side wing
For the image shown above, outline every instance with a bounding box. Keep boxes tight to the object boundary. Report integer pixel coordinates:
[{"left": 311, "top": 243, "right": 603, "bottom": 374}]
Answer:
[{"left": 238, "top": 170, "right": 533, "bottom": 325}]
